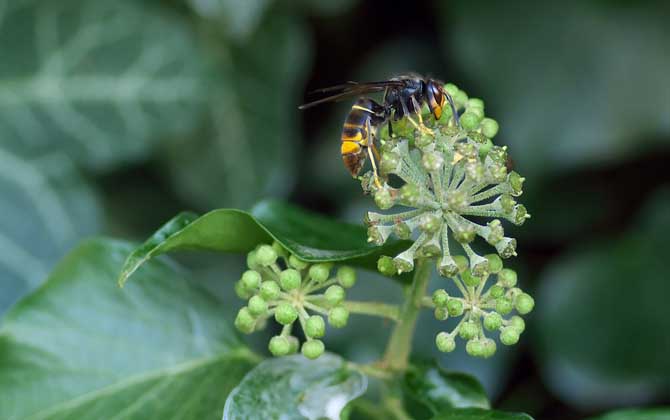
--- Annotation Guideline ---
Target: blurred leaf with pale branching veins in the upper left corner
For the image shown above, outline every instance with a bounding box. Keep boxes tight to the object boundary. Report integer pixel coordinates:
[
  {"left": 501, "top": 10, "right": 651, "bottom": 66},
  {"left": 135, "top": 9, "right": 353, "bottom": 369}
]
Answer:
[{"left": 0, "top": 0, "right": 207, "bottom": 170}]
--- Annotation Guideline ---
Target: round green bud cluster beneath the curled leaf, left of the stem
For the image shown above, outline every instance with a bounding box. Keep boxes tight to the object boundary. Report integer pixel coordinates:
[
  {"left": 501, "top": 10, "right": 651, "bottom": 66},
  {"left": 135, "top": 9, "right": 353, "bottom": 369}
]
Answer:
[{"left": 235, "top": 242, "right": 356, "bottom": 359}]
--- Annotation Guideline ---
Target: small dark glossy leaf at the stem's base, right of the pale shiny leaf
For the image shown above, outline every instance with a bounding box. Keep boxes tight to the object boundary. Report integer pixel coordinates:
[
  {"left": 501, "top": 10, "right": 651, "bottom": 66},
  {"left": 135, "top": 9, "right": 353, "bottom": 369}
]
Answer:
[{"left": 402, "top": 363, "right": 490, "bottom": 414}]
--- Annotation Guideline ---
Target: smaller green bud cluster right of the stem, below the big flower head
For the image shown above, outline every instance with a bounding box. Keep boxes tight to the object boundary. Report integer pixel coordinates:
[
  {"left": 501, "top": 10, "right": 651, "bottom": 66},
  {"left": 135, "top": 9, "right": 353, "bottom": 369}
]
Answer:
[{"left": 432, "top": 262, "right": 534, "bottom": 358}]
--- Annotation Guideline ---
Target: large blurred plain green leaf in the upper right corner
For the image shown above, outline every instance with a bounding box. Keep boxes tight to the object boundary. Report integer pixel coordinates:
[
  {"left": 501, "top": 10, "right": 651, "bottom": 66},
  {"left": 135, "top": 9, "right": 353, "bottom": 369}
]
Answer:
[{"left": 440, "top": 0, "right": 670, "bottom": 177}]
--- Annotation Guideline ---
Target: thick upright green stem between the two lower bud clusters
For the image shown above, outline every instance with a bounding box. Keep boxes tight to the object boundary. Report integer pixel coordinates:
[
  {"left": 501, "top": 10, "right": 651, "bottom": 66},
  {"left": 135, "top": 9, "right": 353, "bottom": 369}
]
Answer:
[{"left": 382, "top": 258, "right": 431, "bottom": 371}]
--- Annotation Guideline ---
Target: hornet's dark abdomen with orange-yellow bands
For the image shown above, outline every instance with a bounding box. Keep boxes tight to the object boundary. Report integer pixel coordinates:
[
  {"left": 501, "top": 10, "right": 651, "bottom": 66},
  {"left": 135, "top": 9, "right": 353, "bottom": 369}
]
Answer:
[{"left": 340, "top": 98, "right": 379, "bottom": 176}]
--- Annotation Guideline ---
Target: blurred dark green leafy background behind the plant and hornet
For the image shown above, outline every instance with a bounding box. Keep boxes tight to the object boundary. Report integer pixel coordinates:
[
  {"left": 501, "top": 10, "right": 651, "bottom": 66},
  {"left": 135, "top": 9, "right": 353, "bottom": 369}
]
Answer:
[{"left": 0, "top": 0, "right": 670, "bottom": 419}]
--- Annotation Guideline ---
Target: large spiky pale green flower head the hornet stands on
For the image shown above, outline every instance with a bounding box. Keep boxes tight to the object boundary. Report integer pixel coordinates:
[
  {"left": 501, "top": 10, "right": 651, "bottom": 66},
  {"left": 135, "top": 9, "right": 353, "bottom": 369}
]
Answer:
[{"left": 362, "top": 84, "right": 530, "bottom": 276}]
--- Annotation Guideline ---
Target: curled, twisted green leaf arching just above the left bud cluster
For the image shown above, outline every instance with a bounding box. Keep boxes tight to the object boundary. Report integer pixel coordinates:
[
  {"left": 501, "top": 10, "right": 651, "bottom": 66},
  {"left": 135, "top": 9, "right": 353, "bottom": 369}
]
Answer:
[{"left": 119, "top": 201, "right": 404, "bottom": 286}]
